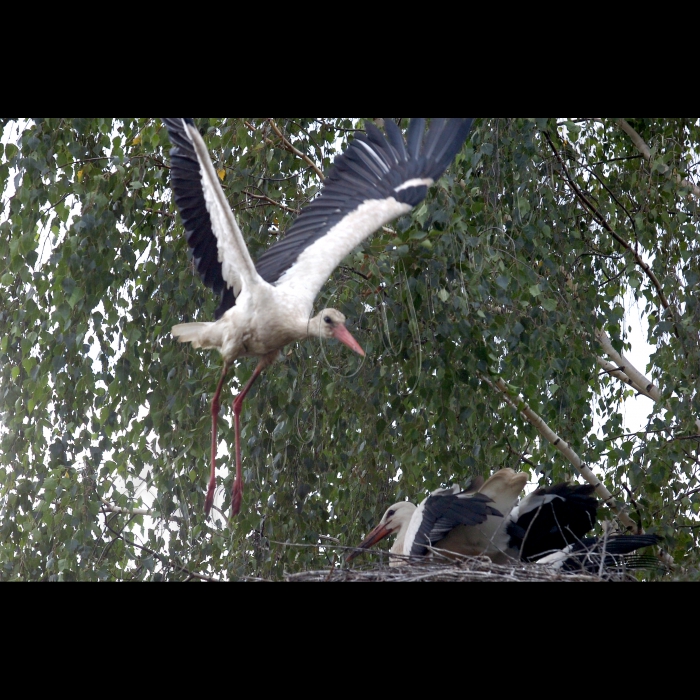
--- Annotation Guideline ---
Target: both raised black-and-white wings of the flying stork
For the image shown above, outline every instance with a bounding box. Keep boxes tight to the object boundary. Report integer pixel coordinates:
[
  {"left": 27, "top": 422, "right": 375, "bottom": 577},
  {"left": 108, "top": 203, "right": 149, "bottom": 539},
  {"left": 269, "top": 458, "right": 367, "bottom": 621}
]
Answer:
[{"left": 163, "top": 118, "right": 473, "bottom": 318}]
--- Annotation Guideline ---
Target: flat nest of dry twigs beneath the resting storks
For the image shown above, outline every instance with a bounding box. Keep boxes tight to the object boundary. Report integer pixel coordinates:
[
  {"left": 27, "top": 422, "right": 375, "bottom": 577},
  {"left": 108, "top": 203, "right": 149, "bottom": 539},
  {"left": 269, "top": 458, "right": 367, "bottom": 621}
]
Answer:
[{"left": 285, "top": 557, "right": 656, "bottom": 582}]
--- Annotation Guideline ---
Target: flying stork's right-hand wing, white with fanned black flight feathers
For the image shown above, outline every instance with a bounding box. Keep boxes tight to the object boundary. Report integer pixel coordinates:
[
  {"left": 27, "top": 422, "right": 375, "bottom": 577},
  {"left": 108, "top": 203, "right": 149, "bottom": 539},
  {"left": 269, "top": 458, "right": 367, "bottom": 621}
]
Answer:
[{"left": 256, "top": 119, "right": 473, "bottom": 310}]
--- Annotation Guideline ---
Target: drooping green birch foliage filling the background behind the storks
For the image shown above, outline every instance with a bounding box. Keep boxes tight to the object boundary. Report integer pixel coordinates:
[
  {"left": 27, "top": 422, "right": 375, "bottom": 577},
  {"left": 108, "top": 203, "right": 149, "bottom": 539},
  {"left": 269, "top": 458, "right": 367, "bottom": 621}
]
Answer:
[{"left": 0, "top": 118, "right": 700, "bottom": 580}]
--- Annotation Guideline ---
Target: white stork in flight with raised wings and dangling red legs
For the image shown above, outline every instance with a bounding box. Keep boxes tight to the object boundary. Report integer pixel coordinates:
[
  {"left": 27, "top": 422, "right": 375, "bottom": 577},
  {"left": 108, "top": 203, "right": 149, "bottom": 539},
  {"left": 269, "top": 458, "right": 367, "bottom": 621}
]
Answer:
[{"left": 163, "top": 118, "right": 473, "bottom": 516}]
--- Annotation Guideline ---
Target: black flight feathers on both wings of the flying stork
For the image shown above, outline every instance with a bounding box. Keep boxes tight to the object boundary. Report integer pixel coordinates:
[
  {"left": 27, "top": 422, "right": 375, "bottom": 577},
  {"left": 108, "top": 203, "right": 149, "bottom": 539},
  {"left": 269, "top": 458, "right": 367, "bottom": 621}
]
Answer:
[{"left": 163, "top": 118, "right": 473, "bottom": 319}]
